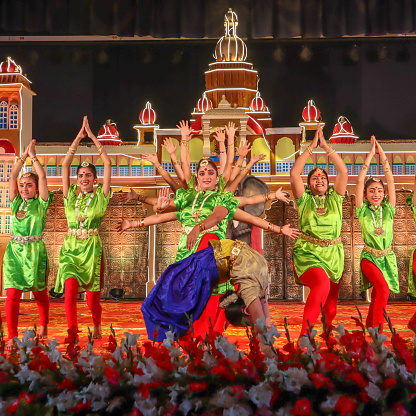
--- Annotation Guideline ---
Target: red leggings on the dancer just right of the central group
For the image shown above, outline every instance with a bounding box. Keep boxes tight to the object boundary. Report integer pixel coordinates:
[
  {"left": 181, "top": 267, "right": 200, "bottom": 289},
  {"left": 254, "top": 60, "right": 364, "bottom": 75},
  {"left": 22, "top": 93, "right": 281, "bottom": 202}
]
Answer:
[{"left": 299, "top": 267, "right": 340, "bottom": 335}]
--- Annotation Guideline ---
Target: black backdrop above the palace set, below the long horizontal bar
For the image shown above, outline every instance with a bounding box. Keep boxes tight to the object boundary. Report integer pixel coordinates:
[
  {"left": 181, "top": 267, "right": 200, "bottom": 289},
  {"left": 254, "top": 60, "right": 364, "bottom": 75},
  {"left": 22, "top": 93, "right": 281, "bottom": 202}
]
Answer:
[{"left": 0, "top": 38, "right": 416, "bottom": 142}]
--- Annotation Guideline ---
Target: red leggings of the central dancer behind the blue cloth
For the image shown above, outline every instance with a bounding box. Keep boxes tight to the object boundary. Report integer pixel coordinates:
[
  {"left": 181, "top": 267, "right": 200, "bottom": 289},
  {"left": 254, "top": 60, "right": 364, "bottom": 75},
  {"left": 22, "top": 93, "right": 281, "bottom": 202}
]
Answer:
[{"left": 193, "top": 233, "right": 226, "bottom": 338}]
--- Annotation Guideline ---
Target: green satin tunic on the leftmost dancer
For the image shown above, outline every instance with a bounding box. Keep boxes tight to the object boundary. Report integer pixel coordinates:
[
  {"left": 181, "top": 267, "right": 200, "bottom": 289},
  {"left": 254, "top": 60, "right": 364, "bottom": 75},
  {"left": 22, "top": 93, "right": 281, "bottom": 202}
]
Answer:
[{"left": 3, "top": 192, "right": 53, "bottom": 292}]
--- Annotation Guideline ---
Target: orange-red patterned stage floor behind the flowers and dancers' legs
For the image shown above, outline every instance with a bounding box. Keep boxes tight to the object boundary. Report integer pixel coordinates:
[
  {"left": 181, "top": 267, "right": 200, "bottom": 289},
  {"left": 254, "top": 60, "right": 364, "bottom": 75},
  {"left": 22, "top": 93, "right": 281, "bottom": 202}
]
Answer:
[{"left": 0, "top": 300, "right": 416, "bottom": 352}]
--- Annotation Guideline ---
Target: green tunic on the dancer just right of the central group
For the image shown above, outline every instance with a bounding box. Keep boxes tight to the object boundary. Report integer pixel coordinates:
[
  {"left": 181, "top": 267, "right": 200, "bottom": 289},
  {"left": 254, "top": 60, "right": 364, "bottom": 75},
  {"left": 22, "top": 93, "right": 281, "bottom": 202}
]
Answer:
[{"left": 293, "top": 186, "right": 344, "bottom": 284}]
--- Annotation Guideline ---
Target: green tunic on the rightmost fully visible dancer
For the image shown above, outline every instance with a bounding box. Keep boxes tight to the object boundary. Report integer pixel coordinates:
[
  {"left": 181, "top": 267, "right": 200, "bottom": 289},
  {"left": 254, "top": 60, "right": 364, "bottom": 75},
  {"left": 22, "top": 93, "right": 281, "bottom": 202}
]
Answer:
[{"left": 355, "top": 198, "right": 400, "bottom": 293}]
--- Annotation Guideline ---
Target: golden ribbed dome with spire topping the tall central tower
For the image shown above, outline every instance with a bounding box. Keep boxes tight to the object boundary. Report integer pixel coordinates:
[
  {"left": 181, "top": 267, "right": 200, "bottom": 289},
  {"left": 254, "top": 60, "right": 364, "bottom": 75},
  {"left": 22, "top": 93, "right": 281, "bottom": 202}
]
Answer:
[{"left": 214, "top": 9, "right": 247, "bottom": 62}]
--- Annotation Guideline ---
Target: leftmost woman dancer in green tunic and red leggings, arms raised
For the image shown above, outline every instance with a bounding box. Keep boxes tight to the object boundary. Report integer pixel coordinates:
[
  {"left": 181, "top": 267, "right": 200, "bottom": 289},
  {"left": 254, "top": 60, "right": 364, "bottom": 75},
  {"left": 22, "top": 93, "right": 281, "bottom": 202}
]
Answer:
[{"left": 3, "top": 140, "right": 53, "bottom": 351}]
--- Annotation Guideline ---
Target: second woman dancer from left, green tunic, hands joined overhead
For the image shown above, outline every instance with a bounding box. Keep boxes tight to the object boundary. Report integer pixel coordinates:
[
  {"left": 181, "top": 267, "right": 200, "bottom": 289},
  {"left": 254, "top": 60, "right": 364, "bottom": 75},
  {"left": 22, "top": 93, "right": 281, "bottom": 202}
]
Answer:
[{"left": 55, "top": 117, "right": 111, "bottom": 338}]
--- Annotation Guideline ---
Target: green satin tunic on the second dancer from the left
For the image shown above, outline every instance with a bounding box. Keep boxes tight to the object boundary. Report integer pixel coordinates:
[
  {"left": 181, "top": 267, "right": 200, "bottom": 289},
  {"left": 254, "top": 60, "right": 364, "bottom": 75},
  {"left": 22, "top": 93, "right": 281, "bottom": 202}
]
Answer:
[{"left": 55, "top": 184, "right": 111, "bottom": 293}]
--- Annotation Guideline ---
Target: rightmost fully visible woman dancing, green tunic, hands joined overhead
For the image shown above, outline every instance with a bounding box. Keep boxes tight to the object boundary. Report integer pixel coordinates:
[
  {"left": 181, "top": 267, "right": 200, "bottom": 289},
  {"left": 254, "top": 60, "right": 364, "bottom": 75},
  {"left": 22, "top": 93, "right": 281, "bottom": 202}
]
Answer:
[{"left": 355, "top": 136, "right": 399, "bottom": 332}]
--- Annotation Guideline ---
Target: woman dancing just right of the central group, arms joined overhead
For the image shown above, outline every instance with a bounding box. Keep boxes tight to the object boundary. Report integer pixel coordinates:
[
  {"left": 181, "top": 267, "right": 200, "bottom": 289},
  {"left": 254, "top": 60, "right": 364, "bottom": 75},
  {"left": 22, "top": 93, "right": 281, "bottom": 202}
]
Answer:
[{"left": 290, "top": 124, "right": 348, "bottom": 336}]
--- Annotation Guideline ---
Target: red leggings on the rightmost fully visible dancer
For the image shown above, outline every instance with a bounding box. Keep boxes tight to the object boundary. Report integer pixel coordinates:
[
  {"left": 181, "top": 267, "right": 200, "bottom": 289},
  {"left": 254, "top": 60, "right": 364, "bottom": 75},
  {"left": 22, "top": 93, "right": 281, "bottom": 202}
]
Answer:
[{"left": 361, "top": 259, "right": 390, "bottom": 331}]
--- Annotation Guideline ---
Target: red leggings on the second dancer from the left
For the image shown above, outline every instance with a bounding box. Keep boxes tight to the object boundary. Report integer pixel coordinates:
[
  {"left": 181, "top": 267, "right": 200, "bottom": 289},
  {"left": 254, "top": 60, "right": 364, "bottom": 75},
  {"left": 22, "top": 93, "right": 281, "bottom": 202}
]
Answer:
[{"left": 65, "top": 278, "right": 102, "bottom": 330}]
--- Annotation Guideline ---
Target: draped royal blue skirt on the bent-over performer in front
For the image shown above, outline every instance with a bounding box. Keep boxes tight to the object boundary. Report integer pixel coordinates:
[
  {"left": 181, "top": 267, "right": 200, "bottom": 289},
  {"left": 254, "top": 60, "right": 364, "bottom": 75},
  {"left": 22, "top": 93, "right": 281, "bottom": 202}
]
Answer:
[{"left": 141, "top": 247, "right": 219, "bottom": 341}]
